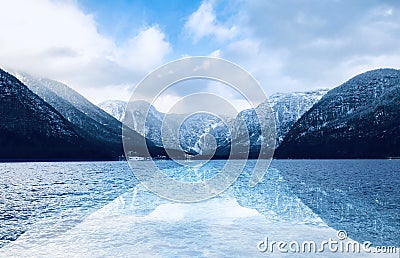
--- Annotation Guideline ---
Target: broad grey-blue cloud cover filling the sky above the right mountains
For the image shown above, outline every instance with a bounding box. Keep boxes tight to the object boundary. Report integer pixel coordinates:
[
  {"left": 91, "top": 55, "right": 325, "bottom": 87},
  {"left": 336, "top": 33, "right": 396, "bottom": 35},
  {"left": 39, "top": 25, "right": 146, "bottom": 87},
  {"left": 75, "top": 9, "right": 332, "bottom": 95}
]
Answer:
[{"left": 192, "top": 0, "right": 400, "bottom": 97}]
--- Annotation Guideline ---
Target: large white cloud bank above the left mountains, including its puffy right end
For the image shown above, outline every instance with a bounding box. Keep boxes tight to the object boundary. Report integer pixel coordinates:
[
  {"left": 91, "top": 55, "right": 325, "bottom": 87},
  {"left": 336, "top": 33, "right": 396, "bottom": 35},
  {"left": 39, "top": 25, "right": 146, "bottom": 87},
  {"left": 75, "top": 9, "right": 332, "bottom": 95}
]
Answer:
[{"left": 0, "top": 0, "right": 170, "bottom": 102}]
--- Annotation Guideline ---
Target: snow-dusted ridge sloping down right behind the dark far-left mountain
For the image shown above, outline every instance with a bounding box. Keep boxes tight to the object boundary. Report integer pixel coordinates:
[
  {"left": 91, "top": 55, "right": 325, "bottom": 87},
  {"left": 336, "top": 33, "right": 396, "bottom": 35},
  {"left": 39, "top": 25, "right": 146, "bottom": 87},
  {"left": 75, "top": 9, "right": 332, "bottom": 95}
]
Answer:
[{"left": 7, "top": 72, "right": 165, "bottom": 159}]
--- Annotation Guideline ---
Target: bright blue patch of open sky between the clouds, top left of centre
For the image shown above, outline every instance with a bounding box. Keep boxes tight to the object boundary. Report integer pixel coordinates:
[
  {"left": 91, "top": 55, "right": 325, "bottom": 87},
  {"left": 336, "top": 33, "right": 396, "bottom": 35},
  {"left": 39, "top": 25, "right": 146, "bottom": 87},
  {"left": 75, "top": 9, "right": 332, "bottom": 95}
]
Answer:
[{"left": 78, "top": 0, "right": 201, "bottom": 45}]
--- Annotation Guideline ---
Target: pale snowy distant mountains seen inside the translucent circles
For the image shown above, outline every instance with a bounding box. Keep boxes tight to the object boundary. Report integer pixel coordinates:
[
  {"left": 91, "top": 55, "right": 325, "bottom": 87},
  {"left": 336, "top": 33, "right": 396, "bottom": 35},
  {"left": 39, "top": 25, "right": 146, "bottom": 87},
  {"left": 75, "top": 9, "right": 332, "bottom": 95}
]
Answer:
[{"left": 119, "top": 101, "right": 274, "bottom": 158}]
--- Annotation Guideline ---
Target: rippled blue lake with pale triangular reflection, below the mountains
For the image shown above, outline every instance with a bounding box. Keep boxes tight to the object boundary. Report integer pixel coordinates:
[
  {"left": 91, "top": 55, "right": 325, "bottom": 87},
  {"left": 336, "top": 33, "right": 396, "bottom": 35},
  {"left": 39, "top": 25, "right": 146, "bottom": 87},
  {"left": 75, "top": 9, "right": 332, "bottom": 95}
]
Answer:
[{"left": 0, "top": 160, "right": 400, "bottom": 257}]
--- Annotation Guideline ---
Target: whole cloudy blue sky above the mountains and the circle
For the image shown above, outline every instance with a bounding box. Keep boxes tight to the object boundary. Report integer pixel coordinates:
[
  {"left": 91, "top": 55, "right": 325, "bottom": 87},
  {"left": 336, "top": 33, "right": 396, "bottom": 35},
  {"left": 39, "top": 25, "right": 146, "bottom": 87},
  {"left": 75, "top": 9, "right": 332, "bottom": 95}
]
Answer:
[{"left": 0, "top": 0, "right": 400, "bottom": 112}]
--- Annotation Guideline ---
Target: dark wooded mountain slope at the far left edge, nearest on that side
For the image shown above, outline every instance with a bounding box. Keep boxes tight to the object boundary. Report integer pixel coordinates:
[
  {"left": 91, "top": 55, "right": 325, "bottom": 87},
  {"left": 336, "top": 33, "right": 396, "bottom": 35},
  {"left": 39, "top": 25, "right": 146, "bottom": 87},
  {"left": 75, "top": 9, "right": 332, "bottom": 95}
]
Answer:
[{"left": 0, "top": 69, "right": 94, "bottom": 160}]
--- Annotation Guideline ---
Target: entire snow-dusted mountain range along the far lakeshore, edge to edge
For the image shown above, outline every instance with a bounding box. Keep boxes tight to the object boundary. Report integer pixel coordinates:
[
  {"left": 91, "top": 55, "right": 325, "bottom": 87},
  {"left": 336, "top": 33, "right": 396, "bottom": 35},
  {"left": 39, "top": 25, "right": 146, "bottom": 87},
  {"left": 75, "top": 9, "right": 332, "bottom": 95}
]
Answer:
[{"left": 0, "top": 69, "right": 400, "bottom": 160}]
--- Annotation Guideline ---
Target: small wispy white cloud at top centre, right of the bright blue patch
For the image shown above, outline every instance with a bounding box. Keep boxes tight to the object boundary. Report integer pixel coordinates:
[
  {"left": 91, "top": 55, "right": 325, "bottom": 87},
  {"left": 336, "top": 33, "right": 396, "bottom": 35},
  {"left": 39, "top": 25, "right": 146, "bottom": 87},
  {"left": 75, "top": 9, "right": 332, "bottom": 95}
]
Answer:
[{"left": 185, "top": 1, "right": 237, "bottom": 41}]
